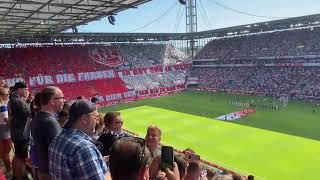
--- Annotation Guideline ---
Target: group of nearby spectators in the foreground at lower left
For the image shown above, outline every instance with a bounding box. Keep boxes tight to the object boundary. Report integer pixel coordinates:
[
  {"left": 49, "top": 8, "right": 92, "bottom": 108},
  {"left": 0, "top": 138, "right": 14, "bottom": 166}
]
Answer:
[{"left": 0, "top": 82, "right": 247, "bottom": 180}]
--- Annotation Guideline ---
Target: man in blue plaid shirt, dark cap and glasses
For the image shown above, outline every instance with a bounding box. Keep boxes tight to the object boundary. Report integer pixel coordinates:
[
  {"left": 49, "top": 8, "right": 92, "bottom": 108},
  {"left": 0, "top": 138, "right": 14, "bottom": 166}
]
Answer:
[{"left": 49, "top": 99, "right": 107, "bottom": 180}]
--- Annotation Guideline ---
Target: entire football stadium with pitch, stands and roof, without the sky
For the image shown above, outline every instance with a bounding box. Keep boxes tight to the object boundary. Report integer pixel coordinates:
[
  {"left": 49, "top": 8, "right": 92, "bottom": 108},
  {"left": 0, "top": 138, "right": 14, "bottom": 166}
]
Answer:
[{"left": 0, "top": 0, "right": 320, "bottom": 180}]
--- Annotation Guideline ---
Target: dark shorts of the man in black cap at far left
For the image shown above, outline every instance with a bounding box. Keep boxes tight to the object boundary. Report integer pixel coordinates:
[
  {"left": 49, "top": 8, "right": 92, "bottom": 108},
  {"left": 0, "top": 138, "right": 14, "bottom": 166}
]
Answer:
[{"left": 13, "top": 139, "right": 31, "bottom": 160}]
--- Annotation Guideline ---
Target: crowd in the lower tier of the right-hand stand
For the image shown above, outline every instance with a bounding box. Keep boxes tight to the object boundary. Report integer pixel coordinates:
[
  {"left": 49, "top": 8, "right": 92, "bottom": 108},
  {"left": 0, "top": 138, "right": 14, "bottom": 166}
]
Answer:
[{"left": 191, "top": 67, "right": 320, "bottom": 97}]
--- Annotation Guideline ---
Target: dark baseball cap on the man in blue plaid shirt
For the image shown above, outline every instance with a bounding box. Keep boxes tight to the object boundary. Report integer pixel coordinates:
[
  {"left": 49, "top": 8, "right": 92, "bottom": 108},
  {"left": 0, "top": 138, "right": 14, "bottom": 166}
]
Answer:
[{"left": 64, "top": 99, "right": 97, "bottom": 128}]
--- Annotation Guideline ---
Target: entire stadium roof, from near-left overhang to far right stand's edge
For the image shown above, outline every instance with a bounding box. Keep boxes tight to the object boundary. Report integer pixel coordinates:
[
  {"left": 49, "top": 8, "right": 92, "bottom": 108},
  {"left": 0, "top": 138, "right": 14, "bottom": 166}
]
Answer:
[{"left": 0, "top": 5, "right": 320, "bottom": 43}]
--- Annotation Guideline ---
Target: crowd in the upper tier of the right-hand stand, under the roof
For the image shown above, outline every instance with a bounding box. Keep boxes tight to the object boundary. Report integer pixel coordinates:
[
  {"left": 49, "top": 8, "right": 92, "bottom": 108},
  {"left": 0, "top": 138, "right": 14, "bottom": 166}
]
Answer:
[{"left": 195, "top": 29, "right": 320, "bottom": 60}]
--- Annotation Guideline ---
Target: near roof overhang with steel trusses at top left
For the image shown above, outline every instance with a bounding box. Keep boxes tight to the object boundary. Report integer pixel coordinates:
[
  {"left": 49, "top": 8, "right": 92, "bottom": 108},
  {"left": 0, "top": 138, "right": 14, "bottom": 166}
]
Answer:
[{"left": 0, "top": 0, "right": 150, "bottom": 39}]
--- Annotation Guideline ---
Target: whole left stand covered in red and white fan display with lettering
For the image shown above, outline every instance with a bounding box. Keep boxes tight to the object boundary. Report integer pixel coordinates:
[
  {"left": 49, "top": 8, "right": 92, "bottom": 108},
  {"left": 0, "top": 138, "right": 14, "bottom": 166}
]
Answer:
[{"left": 0, "top": 44, "right": 190, "bottom": 102}]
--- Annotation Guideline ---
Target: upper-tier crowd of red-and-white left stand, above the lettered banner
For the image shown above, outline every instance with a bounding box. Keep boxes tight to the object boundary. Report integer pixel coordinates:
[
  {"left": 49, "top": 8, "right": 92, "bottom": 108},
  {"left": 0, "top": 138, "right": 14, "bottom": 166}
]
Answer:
[{"left": 0, "top": 44, "right": 189, "bottom": 78}]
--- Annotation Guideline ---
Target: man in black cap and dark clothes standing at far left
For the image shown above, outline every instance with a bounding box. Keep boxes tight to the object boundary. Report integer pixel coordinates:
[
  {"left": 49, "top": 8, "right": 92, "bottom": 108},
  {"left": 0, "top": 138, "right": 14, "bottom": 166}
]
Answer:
[{"left": 8, "top": 82, "right": 31, "bottom": 180}]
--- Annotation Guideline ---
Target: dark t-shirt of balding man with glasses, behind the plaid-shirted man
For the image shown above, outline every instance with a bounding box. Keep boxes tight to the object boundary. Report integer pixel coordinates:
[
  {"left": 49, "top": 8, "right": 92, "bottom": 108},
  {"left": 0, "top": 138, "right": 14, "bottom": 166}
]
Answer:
[{"left": 31, "top": 111, "right": 61, "bottom": 173}]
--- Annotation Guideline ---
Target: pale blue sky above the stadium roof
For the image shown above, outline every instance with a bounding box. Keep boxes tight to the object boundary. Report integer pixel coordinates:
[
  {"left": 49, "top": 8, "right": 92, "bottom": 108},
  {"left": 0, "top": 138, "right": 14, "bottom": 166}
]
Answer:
[{"left": 69, "top": 0, "right": 320, "bottom": 32}]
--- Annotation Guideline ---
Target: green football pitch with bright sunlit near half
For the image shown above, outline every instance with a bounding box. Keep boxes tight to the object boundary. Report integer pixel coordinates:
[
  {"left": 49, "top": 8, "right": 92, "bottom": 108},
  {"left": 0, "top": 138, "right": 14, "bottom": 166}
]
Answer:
[{"left": 101, "top": 91, "right": 320, "bottom": 180}]
